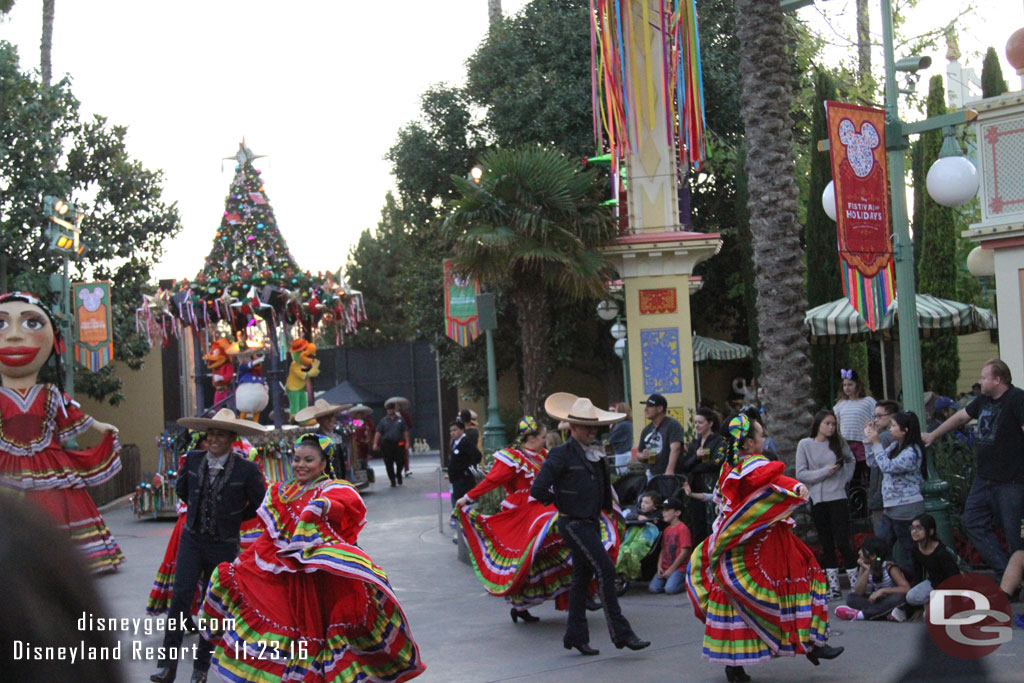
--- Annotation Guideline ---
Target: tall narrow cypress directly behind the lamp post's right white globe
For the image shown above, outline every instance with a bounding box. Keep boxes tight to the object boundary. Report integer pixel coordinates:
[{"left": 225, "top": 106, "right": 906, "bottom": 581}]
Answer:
[{"left": 918, "top": 76, "right": 959, "bottom": 396}]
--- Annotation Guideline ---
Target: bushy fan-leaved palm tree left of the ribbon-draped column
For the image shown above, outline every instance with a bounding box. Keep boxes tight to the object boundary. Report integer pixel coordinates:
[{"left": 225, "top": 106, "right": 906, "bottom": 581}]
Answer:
[{"left": 444, "top": 145, "right": 615, "bottom": 415}]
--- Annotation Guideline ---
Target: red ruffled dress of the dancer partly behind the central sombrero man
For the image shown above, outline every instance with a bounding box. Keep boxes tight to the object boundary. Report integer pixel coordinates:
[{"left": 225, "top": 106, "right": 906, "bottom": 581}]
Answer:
[{"left": 459, "top": 447, "right": 621, "bottom": 609}]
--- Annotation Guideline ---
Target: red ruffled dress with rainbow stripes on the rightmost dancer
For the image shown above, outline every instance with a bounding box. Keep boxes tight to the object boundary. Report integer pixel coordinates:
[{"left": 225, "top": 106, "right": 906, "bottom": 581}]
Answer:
[{"left": 686, "top": 455, "right": 828, "bottom": 666}]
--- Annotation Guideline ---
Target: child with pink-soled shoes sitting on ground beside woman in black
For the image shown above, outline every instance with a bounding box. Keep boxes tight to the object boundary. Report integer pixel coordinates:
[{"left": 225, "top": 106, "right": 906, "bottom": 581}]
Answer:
[{"left": 836, "top": 536, "right": 910, "bottom": 622}]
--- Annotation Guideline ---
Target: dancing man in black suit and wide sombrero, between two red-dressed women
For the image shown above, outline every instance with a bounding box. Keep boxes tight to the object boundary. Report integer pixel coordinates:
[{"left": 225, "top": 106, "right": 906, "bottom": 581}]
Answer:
[{"left": 529, "top": 392, "right": 650, "bottom": 654}]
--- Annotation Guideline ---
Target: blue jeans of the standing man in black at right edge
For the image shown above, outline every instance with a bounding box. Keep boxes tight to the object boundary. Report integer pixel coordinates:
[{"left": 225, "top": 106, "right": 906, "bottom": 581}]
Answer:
[{"left": 963, "top": 477, "right": 1024, "bottom": 572}]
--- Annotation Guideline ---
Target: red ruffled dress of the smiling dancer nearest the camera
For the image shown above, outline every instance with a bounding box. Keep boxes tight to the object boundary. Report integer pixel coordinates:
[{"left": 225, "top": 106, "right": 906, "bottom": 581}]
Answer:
[{"left": 201, "top": 477, "right": 425, "bottom": 683}]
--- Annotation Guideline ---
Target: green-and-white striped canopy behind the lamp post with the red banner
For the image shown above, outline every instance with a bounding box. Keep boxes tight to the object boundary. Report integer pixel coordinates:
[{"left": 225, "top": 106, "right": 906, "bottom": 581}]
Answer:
[{"left": 804, "top": 294, "right": 998, "bottom": 344}]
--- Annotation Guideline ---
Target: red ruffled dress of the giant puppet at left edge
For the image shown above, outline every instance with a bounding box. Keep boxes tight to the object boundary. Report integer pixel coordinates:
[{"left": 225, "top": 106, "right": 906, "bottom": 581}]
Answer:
[{"left": 0, "top": 384, "right": 125, "bottom": 571}]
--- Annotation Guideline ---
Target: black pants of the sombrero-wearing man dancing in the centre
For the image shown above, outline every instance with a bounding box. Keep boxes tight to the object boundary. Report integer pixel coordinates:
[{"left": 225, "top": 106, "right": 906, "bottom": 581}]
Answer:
[{"left": 558, "top": 518, "right": 633, "bottom": 645}]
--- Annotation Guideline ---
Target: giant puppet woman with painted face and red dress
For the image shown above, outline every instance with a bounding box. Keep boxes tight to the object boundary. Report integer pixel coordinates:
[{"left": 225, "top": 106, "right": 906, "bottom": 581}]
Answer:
[{"left": 0, "top": 292, "right": 124, "bottom": 571}]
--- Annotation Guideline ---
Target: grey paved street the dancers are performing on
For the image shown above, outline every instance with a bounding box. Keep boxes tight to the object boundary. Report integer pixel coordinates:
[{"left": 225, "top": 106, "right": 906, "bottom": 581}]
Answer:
[{"left": 89, "top": 456, "right": 1024, "bottom": 683}]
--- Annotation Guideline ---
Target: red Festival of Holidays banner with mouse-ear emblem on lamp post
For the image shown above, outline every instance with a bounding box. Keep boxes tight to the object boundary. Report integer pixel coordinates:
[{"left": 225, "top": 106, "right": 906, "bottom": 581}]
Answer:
[{"left": 825, "top": 101, "right": 895, "bottom": 330}]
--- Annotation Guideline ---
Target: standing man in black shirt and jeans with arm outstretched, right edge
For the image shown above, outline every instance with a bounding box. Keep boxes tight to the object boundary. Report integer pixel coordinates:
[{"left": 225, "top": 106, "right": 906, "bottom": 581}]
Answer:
[{"left": 922, "top": 358, "right": 1024, "bottom": 572}]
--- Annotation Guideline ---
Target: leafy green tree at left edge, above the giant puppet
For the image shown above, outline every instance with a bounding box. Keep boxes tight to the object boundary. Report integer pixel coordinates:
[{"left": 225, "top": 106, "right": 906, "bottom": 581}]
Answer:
[{"left": 0, "top": 42, "right": 181, "bottom": 403}]
